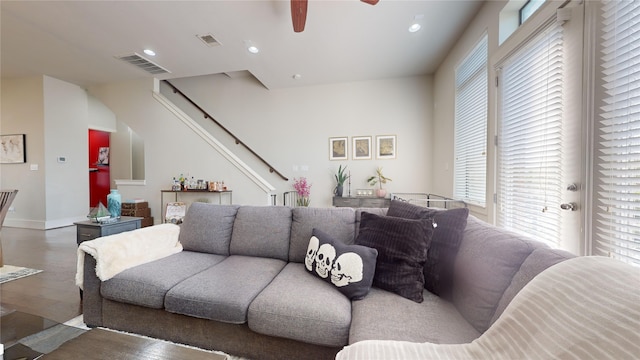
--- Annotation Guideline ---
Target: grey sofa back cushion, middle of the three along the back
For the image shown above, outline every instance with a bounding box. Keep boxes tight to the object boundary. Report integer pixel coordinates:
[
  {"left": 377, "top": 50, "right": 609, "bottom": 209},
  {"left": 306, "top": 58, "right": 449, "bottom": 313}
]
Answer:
[{"left": 230, "top": 206, "right": 292, "bottom": 261}]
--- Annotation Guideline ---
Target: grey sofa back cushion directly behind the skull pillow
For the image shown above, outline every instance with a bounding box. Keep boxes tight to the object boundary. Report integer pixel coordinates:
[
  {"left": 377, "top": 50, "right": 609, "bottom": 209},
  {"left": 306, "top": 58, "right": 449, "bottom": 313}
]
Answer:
[{"left": 289, "top": 207, "right": 355, "bottom": 263}]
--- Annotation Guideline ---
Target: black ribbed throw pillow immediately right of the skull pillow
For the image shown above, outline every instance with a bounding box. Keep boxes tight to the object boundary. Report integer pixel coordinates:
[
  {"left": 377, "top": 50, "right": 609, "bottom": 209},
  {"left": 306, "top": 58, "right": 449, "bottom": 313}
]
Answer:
[{"left": 356, "top": 212, "right": 432, "bottom": 303}]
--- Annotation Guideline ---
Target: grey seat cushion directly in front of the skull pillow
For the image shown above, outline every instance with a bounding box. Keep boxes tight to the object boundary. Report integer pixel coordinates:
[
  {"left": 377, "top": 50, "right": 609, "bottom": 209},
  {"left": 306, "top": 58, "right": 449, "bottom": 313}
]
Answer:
[{"left": 249, "top": 263, "right": 351, "bottom": 347}]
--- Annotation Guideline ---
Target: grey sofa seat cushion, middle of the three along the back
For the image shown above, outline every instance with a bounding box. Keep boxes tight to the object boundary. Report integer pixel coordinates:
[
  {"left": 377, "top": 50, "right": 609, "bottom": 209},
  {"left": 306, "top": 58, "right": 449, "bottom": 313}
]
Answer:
[{"left": 165, "top": 255, "right": 285, "bottom": 324}]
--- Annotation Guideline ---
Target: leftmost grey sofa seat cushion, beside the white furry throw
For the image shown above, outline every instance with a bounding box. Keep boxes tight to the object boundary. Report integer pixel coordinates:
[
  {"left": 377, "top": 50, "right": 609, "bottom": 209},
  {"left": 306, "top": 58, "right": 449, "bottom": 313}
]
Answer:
[{"left": 100, "top": 251, "right": 226, "bottom": 309}]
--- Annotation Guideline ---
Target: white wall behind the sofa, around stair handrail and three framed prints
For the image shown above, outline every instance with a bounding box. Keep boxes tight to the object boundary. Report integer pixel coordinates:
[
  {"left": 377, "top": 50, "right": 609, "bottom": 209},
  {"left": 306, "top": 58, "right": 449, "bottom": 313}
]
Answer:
[{"left": 90, "top": 76, "right": 433, "bottom": 220}]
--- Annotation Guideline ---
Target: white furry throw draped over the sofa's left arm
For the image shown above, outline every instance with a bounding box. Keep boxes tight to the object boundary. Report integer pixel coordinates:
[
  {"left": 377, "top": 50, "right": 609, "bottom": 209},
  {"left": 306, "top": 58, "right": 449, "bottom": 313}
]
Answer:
[{"left": 76, "top": 224, "right": 182, "bottom": 289}]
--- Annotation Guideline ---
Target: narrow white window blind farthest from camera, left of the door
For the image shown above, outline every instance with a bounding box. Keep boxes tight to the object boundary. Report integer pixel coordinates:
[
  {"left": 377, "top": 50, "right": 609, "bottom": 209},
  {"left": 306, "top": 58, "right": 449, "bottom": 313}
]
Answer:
[{"left": 453, "top": 34, "right": 489, "bottom": 206}]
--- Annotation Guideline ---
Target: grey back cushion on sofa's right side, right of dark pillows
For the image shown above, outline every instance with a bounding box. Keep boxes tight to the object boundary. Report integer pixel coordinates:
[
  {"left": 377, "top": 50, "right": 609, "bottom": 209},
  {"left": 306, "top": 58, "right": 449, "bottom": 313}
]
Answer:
[{"left": 452, "top": 216, "right": 548, "bottom": 333}]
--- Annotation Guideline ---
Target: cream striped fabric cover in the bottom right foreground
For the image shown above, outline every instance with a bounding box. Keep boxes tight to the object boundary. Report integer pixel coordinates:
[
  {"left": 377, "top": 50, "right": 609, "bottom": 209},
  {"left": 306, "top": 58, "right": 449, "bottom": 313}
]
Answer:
[{"left": 336, "top": 256, "right": 640, "bottom": 360}]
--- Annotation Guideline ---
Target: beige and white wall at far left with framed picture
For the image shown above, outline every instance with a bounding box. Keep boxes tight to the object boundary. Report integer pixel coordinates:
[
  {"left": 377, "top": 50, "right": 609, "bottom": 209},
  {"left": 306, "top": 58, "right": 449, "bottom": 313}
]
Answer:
[{"left": 0, "top": 76, "right": 89, "bottom": 229}]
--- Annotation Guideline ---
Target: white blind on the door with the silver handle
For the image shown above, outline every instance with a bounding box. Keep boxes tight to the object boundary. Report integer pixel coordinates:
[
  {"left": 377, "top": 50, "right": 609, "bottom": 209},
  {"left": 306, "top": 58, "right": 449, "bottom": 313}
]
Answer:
[{"left": 497, "top": 23, "right": 564, "bottom": 247}]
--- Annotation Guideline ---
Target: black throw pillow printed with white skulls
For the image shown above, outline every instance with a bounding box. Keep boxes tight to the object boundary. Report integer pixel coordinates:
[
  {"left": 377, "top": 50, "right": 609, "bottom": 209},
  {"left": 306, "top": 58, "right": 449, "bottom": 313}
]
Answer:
[{"left": 304, "top": 228, "right": 378, "bottom": 300}]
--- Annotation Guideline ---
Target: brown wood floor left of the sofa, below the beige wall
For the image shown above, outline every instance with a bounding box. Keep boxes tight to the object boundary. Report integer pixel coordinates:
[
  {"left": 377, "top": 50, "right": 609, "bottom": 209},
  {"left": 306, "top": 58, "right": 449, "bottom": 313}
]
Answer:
[{"left": 0, "top": 226, "right": 82, "bottom": 323}]
